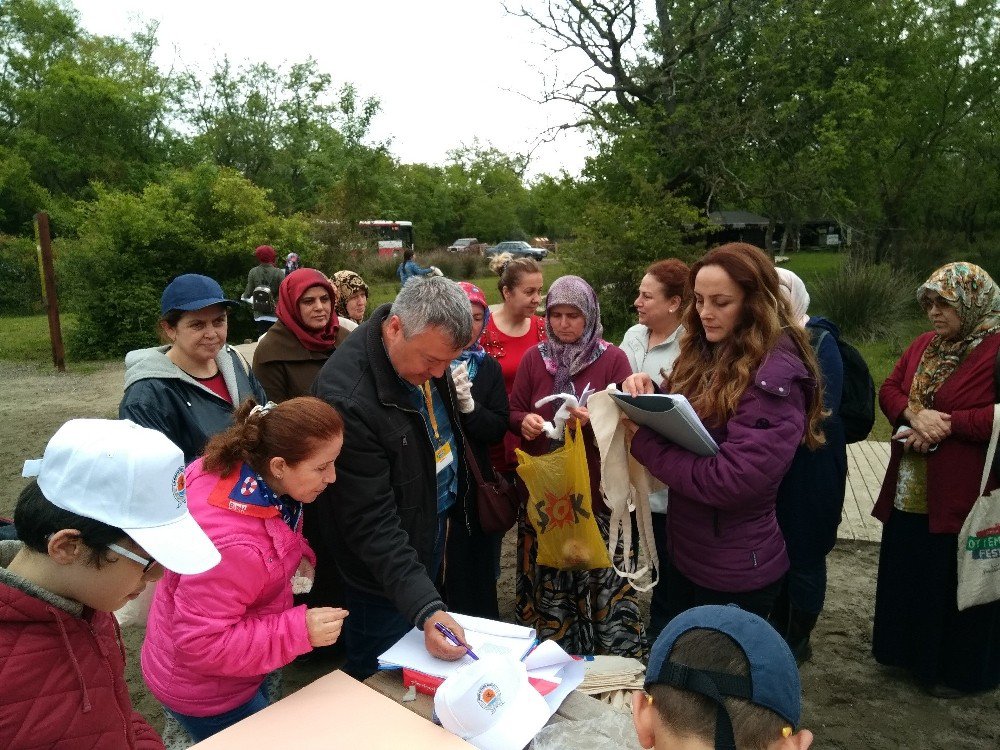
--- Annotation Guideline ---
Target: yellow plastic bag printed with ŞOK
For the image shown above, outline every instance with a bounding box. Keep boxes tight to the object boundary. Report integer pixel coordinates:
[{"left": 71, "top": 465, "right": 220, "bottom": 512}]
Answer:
[{"left": 516, "top": 427, "right": 611, "bottom": 570}]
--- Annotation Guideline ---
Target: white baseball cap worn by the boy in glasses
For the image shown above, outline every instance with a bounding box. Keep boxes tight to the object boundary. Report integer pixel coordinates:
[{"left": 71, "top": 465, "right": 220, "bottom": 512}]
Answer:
[{"left": 22, "top": 419, "right": 222, "bottom": 574}]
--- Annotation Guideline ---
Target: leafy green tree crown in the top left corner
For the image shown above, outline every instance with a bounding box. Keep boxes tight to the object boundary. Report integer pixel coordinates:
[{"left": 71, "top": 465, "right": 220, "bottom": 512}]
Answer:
[{"left": 0, "top": 0, "right": 175, "bottom": 197}]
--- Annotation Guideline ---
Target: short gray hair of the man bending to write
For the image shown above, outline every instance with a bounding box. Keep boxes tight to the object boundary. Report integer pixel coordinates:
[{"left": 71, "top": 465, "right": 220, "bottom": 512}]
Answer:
[{"left": 389, "top": 276, "right": 472, "bottom": 349}]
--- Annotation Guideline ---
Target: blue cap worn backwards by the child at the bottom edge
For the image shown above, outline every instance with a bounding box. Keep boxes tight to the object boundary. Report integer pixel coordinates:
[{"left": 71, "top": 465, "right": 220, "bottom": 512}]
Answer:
[{"left": 646, "top": 604, "right": 802, "bottom": 747}]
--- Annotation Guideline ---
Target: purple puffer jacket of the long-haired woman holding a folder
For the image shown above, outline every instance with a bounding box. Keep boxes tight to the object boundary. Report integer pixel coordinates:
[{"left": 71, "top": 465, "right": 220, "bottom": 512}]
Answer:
[{"left": 632, "top": 335, "right": 816, "bottom": 593}]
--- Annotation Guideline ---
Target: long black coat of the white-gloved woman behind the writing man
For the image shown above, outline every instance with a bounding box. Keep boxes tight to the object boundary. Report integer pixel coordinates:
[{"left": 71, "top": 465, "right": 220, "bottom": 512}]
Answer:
[{"left": 444, "top": 354, "right": 510, "bottom": 619}]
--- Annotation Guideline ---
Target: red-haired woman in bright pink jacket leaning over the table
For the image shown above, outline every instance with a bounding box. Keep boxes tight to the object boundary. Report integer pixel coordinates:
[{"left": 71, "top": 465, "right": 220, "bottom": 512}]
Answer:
[{"left": 142, "top": 397, "right": 347, "bottom": 740}]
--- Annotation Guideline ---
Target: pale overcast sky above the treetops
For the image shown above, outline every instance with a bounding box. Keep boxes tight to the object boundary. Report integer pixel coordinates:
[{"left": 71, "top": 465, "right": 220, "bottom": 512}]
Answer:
[{"left": 72, "top": 0, "right": 608, "bottom": 174}]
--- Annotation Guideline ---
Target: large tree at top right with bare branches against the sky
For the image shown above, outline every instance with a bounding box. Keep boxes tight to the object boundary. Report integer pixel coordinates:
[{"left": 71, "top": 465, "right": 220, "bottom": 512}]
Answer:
[{"left": 517, "top": 0, "right": 1000, "bottom": 264}]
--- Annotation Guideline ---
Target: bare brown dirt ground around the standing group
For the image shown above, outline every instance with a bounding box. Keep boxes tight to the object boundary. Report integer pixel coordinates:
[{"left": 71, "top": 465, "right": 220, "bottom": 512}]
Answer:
[{"left": 0, "top": 362, "right": 1000, "bottom": 750}]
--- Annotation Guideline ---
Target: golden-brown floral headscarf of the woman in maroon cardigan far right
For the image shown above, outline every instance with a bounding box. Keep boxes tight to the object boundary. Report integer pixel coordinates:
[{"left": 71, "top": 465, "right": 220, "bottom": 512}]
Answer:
[{"left": 909, "top": 262, "right": 1000, "bottom": 412}]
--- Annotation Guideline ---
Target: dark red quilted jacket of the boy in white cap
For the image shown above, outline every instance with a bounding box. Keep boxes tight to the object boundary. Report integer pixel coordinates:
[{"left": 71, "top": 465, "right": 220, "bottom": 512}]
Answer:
[{"left": 0, "top": 542, "right": 163, "bottom": 750}]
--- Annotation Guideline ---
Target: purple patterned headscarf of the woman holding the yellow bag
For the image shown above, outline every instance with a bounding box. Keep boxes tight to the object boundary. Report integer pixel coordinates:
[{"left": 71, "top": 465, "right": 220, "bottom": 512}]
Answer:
[{"left": 538, "top": 276, "right": 610, "bottom": 393}]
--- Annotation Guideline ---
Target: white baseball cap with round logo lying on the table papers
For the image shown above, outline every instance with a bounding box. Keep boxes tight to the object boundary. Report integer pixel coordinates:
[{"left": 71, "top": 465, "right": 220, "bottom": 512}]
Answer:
[{"left": 434, "top": 655, "right": 552, "bottom": 750}]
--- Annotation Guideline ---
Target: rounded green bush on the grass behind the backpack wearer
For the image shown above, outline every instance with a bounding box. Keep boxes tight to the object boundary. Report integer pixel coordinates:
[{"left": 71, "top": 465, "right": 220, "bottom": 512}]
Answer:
[{"left": 809, "top": 258, "right": 920, "bottom": 342}]
